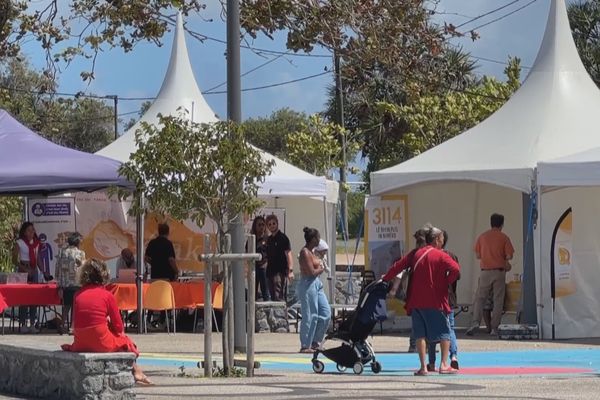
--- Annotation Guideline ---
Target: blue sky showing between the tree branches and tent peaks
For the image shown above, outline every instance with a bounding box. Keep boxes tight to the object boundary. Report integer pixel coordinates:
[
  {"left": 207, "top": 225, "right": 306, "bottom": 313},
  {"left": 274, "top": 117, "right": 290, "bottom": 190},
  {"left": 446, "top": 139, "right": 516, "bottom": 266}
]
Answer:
[{"left": 26, "top": 0, "right": 550, "bottom": 131}]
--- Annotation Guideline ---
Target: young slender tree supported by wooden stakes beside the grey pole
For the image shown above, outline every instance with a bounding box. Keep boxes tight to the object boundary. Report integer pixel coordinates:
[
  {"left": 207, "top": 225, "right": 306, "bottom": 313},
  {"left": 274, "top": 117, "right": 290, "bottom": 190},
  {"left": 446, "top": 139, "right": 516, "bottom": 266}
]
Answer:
[{"left": 119, "top": 116, "right": 274, "bottom": 374}]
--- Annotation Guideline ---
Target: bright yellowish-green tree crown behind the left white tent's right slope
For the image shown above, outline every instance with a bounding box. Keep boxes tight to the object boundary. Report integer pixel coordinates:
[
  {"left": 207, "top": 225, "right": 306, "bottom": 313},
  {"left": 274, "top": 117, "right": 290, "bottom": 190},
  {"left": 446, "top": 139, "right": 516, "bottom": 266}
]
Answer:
[{"left": 285, "top": 115, "right": 358, "bottom": 177}]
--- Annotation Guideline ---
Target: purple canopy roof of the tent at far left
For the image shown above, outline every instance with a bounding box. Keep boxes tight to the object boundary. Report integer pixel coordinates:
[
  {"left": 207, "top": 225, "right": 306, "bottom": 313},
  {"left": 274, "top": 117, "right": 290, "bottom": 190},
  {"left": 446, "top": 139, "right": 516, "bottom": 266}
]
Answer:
[{"left": 0, "top": 110, "right": 131, "bottom": 195}]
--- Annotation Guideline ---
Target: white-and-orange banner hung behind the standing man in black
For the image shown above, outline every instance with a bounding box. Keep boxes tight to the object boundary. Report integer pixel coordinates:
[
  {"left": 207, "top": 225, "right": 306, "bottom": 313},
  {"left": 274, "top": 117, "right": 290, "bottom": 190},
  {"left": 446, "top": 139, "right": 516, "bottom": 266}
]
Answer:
[{"left": 75, "top": 193, "right": 216, "bottom": 276}]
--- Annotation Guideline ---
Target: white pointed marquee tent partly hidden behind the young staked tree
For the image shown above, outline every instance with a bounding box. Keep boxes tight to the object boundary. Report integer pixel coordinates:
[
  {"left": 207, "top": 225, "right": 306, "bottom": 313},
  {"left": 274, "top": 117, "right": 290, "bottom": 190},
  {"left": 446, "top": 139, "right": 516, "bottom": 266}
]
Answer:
[{"left": 96, "top": 14, "right": 338, "bottom": 276}]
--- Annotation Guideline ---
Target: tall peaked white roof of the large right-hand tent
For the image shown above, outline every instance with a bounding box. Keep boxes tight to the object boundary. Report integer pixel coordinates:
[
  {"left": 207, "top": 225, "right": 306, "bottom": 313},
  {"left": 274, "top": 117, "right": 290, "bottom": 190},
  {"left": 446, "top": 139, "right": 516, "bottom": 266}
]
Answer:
[{"left": 371, "top": 0, "right": 600, "bottom": 194}]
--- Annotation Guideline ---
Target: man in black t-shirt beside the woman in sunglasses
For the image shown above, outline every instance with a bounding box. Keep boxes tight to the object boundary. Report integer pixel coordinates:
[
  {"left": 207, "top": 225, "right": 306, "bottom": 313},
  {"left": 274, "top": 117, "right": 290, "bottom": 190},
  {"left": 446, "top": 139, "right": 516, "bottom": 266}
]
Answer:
[{"left": 266, "top": 215, "right": 294, "bottom": 301}]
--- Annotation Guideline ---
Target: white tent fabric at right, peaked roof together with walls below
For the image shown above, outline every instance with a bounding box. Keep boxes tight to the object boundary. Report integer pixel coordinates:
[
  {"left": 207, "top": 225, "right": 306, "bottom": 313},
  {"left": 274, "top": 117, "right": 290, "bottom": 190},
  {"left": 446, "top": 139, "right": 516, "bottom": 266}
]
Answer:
[{"left": 371, "top": 0, "right": 600, "bottom": 338}]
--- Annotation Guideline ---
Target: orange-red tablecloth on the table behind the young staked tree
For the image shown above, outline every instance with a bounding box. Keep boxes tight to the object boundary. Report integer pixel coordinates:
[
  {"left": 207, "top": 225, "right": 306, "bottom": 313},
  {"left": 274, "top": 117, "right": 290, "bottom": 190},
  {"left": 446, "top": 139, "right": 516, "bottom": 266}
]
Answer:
[{"left": 107, "top": 281, "right": 219, "bottom": 311}]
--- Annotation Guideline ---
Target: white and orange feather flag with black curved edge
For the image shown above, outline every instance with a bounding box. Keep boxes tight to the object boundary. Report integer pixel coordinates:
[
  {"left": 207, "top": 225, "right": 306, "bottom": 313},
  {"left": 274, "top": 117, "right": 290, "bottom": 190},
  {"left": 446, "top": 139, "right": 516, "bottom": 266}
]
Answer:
[{"left": 550, "top": 208, "right": 577, "bottom": 298}]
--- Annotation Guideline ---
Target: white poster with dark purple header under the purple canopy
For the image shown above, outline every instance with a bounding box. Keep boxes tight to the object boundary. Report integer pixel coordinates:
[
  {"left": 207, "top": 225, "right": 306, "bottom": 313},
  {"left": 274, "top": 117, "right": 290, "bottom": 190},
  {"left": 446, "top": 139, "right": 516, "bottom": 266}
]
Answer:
[{"left": 27, "top": 196, "right": 76, "bottom": 275}]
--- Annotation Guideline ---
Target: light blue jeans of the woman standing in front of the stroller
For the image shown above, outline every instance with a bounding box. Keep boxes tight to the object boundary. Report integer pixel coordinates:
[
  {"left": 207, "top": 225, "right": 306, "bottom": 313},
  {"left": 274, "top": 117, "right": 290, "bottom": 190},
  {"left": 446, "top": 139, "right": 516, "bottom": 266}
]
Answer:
[{"left": 297, "top": 276, "right": 331, "bottom": 349}]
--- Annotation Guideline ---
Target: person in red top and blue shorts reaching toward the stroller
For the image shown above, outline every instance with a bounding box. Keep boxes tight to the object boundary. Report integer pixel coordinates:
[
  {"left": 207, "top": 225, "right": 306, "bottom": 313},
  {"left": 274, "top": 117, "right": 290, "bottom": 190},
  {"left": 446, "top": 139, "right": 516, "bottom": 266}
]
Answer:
[{"left": 383, "top": 227, "right": 460, "bottom": 376}]
